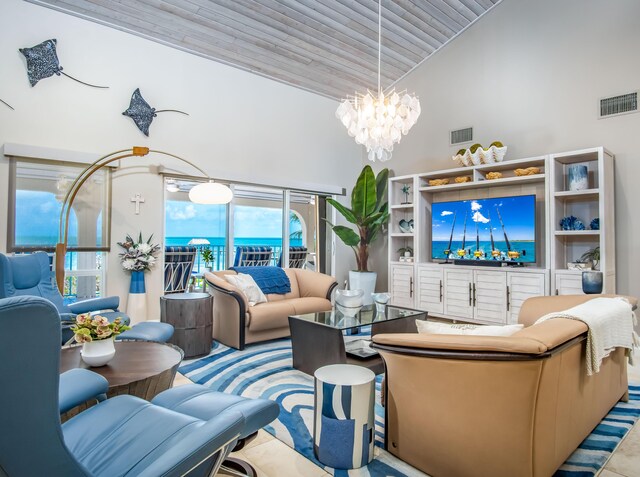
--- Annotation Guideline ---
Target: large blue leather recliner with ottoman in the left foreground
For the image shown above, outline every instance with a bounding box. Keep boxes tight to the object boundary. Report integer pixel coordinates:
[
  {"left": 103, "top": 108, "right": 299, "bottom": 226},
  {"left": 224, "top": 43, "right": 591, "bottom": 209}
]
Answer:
[{"left": 0, "top": 296, "right": 279, "bottom": 477}]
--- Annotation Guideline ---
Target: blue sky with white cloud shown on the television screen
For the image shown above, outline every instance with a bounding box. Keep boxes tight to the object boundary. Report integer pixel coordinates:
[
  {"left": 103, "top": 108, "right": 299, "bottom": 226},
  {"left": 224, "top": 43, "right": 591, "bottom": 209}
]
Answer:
[{"left": 431, "top": 195, "right": 535, "bottom": 241}]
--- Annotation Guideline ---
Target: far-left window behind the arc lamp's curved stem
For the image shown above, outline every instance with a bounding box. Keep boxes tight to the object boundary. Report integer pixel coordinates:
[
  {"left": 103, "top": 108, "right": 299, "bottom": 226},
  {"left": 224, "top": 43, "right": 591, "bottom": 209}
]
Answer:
[{"left": 7, "top": 158, "right": 111, "bottom": 301}]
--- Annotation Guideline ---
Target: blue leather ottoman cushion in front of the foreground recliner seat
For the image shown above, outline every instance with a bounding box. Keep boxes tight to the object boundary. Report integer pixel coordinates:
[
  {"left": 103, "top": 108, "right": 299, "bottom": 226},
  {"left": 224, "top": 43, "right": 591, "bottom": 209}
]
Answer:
[{"left": 151, "top": 384, "right": 280, "bottom": 439}]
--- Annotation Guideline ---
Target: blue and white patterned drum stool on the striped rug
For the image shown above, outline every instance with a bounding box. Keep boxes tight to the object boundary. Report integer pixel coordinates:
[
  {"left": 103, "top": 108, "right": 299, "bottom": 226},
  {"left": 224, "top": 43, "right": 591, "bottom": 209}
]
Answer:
[{"left": 313, "top": 364, "right": 376, "bottom": 469}]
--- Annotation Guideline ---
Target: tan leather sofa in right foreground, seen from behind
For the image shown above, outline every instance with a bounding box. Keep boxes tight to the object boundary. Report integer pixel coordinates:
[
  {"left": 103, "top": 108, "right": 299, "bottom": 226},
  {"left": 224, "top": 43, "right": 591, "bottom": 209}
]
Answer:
[{"left": 373, "top": 295, "right": 635, "bottom": 477}]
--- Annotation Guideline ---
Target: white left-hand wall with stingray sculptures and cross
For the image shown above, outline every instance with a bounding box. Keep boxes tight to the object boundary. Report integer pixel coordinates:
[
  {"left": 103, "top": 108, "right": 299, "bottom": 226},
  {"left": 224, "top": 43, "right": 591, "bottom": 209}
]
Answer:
[{"left": 0, "top": 0, "right": 361, "bottom": 318}]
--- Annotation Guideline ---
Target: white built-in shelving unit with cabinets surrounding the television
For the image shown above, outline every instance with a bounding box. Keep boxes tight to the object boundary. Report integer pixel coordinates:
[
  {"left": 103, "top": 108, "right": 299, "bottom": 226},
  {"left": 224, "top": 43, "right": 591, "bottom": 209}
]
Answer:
[{"left": 389, "top": 147, "right": 615, "bottom": 323}]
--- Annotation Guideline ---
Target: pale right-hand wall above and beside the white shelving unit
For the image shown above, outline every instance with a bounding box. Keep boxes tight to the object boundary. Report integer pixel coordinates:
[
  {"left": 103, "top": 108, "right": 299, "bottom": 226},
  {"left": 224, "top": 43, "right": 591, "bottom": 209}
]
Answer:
[{"left": 388, "top": 0, "right": 640, "bottom": 296}]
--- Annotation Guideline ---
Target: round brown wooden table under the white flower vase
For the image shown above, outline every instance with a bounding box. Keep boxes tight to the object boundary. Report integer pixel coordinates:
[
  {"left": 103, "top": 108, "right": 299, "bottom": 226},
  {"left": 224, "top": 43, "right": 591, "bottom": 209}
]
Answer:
[{"left": 60, "top": 341, "right": 183, "bottom": 422}]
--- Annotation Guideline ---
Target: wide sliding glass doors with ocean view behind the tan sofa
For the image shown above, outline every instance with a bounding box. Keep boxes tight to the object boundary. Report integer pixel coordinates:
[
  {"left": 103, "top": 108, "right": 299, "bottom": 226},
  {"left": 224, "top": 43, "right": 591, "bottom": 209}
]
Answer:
[{"left": 165, "top": 178, "right": 330, "bottom": 277}]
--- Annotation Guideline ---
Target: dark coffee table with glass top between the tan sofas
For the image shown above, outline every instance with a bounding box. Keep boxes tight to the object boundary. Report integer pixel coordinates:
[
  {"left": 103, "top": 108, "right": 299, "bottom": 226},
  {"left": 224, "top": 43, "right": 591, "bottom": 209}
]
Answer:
[{"left": 289, "top": 305, "right": 427, "bottom": 375}]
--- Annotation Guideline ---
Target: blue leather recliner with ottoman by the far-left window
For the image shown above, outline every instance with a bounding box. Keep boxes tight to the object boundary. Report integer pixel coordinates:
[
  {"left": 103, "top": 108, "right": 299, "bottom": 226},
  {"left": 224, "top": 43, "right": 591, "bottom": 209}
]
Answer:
[{"left": 0, "top": 252, "right": 173, "bottom": 343}]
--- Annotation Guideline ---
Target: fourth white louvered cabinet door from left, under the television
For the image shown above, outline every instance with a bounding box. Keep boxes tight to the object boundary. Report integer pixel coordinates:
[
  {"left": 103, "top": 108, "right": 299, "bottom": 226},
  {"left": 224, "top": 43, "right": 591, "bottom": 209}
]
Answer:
[{"left": 473, "top": 270, "right": 507, "bottom": 324}]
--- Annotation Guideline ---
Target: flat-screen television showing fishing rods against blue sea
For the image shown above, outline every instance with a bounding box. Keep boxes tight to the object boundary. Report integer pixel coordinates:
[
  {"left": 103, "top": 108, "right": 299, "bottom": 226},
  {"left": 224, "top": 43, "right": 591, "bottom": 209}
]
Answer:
[{"left": 431, "top": 195, "right": 536, "bottom": 263}]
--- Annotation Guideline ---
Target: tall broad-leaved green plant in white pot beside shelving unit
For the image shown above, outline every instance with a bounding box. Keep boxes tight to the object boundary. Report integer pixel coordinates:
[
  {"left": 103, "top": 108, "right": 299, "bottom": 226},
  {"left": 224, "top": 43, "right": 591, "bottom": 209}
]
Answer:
[{"left": 327, "top": 165, "right": 389, "bottom": 272}]
